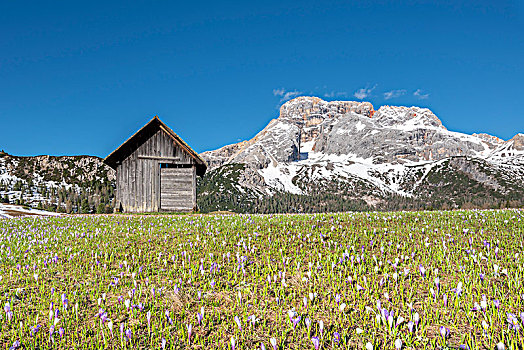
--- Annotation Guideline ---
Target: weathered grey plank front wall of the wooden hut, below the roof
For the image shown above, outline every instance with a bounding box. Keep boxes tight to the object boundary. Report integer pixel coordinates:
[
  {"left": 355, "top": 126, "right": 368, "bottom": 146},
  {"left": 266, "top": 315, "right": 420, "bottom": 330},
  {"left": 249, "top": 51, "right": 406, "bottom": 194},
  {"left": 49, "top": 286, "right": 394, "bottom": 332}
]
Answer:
[{"left": 116, "top": 129, "right": 196, "bottom": 212}]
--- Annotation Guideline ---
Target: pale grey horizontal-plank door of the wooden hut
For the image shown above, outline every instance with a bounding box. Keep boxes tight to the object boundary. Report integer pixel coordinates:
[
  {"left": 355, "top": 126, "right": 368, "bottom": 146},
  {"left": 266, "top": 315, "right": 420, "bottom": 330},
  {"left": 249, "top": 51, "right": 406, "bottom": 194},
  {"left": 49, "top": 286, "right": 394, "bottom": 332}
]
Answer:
[{"left": 160, "top": 166, "right": 194, "bottom": 211}]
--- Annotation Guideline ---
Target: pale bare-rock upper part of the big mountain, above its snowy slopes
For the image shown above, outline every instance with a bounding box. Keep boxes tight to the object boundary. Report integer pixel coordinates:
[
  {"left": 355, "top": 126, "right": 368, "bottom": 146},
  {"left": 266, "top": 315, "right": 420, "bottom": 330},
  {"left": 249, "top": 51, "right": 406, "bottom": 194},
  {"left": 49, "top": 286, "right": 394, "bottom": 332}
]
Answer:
[{"left": 202, "top": 96, "right": 524, "bottom": 169}]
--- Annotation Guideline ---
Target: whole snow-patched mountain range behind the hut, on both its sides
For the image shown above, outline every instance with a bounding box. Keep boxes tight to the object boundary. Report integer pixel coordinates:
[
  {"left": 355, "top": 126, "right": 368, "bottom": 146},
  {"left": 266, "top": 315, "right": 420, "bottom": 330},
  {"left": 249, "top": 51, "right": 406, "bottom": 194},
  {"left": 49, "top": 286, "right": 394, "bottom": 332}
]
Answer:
[{"left": 0, "top": 96, "right": 524, "bottom": 213}]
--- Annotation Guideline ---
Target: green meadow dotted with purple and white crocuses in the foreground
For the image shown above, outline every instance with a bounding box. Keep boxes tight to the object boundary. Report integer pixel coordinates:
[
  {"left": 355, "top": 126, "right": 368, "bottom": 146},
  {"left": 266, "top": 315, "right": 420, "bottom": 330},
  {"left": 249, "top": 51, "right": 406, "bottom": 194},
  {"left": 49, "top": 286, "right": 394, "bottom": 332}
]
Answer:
[{"left": 0, "top": 210, "right": 524, "bottom": 349}]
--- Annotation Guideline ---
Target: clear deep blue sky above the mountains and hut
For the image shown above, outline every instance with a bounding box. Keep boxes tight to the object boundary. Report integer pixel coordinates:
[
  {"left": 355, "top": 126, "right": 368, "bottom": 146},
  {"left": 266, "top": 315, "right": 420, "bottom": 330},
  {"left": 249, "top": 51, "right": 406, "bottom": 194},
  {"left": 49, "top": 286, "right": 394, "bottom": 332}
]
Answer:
[{"left": 0, "top": 0, "right": 524, "bottom": 157}]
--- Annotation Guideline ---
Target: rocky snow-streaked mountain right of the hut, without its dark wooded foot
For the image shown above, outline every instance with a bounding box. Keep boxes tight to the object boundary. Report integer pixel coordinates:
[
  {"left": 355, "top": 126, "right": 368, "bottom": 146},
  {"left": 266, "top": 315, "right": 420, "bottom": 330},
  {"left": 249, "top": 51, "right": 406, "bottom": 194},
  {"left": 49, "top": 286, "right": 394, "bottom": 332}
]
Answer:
[{"left": 202, "top": 97, "right": 524, "bottom": 211}]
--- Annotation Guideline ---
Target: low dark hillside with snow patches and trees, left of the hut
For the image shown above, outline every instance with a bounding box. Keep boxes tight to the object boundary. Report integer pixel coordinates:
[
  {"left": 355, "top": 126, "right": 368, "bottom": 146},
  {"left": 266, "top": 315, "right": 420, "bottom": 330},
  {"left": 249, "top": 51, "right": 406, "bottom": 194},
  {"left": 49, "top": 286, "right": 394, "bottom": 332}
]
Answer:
[{"left": 0, "top": 152, "right": 115, "bottom": 212}]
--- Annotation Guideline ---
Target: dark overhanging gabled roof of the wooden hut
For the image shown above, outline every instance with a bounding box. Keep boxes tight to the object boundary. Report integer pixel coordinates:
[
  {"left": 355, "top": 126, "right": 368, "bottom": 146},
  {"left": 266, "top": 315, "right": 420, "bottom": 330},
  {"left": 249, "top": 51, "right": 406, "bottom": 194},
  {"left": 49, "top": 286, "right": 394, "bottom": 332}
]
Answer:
[{"left": 104, "top": 116, "right": 207, "bottom": 176}]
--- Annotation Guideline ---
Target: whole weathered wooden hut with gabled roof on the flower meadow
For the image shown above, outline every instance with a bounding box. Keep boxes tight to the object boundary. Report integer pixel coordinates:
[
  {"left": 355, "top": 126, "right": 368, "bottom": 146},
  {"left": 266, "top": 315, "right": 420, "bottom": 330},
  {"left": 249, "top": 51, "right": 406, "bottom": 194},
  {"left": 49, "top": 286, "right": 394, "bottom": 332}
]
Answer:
[{"left": 104, "top": 116, "right": 207, "bottom": 213}]
